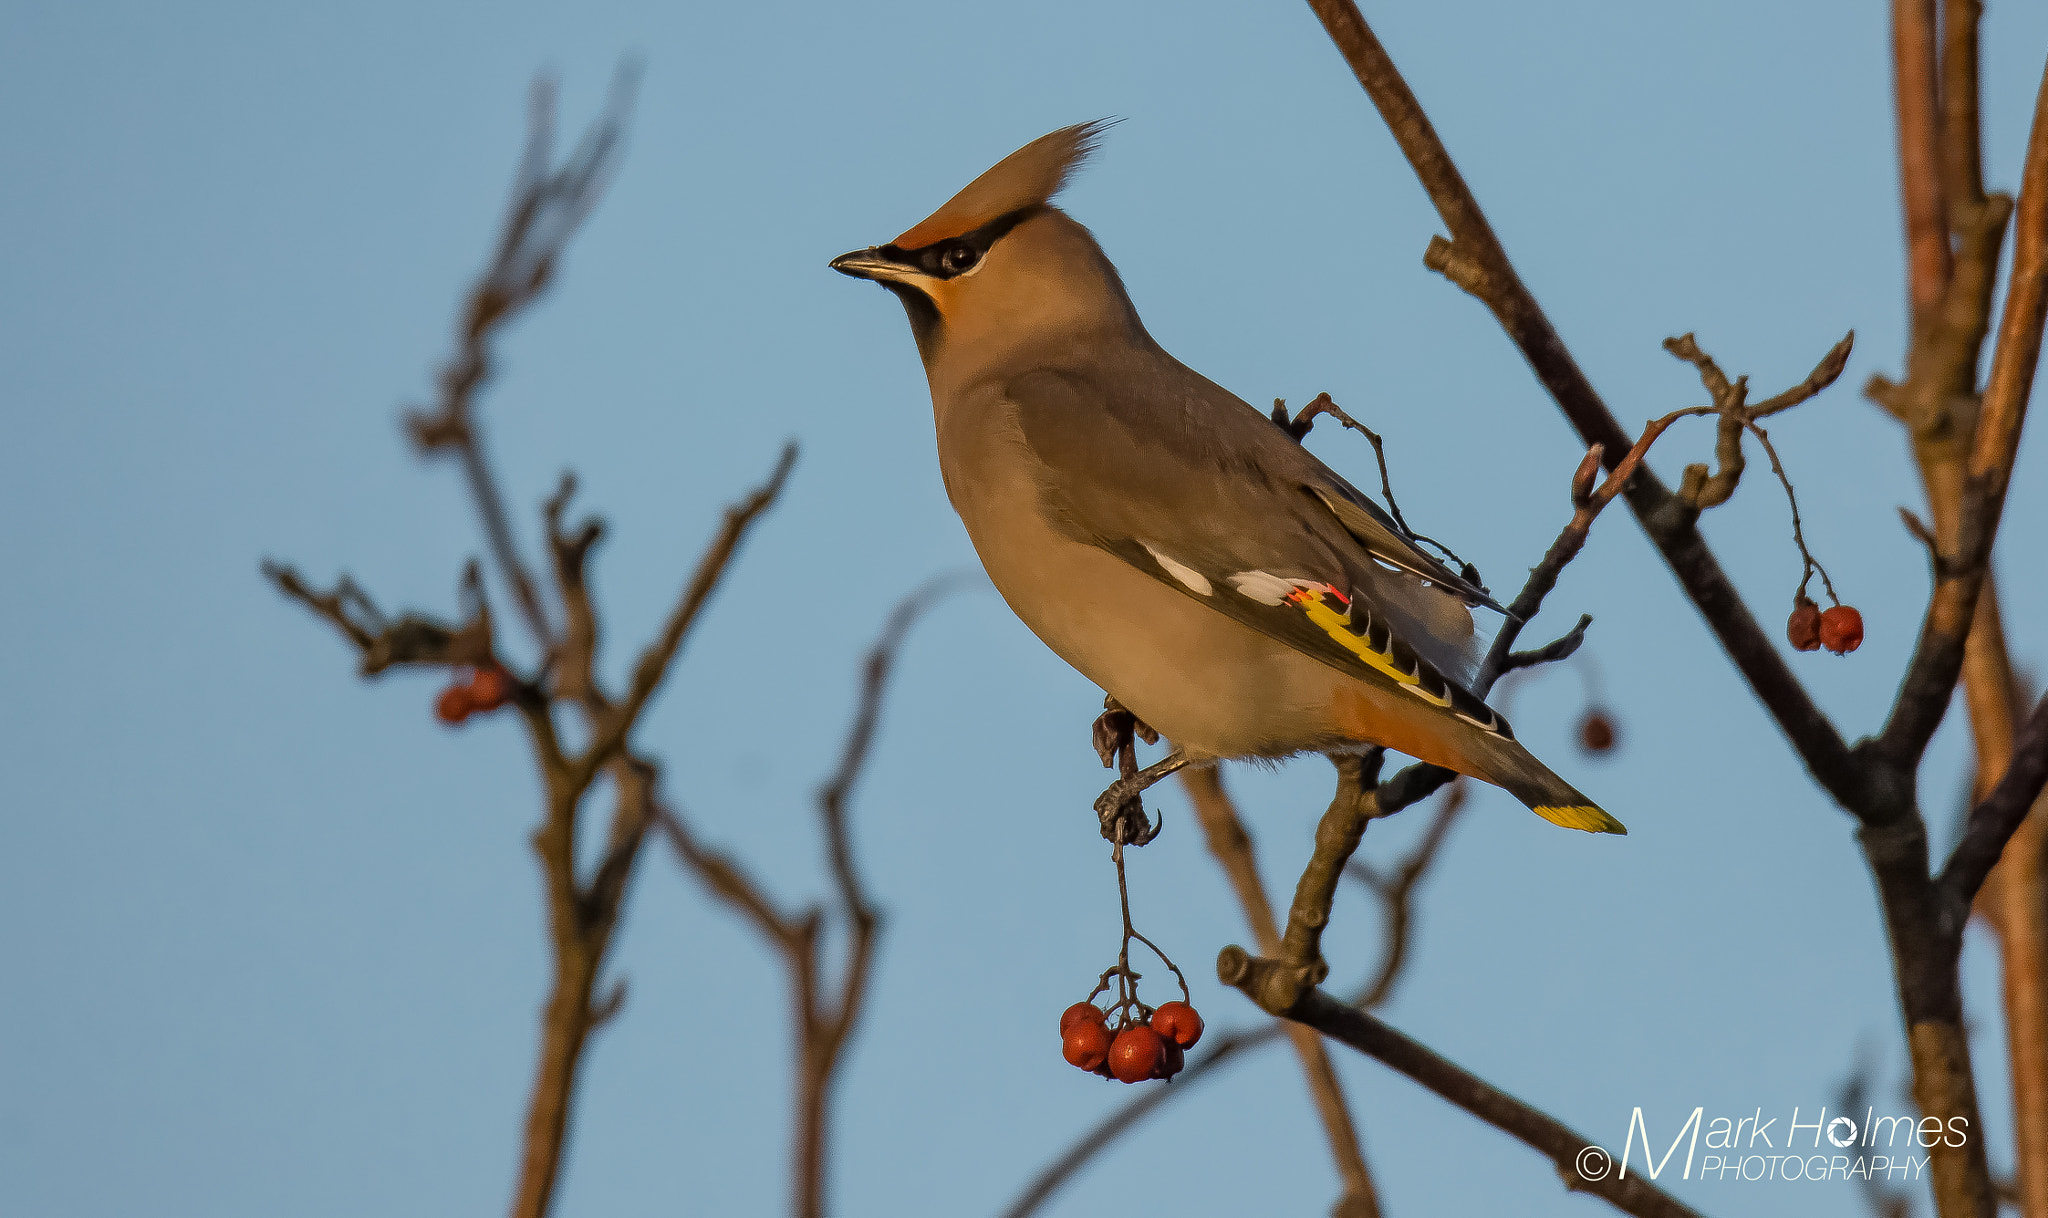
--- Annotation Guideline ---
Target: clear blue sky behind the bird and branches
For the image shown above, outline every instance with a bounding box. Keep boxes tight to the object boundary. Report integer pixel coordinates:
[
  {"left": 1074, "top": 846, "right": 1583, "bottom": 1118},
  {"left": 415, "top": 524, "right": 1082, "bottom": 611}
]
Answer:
[{"left": 0, "top": 0, "right": 2048, "bottom": 1216}]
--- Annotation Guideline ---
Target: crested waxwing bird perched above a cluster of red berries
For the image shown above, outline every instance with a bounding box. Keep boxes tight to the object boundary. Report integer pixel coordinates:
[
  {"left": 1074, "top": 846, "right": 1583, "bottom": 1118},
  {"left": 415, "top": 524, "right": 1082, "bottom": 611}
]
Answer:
[{"left": 831, "top": 123, "right": 1626, "bottom": 833}]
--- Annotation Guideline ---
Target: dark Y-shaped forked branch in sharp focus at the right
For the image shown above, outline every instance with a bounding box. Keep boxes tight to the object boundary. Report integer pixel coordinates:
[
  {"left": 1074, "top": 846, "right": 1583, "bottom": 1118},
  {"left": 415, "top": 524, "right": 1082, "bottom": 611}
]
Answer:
[{"left": 1309, "top": 0, "right": 2048, "bottom": 1214}]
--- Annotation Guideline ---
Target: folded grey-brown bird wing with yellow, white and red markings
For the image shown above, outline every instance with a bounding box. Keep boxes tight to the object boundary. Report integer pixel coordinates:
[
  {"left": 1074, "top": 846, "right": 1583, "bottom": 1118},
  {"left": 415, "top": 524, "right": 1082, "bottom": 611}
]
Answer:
[{"left": 999, "top": 362, "right": 1505, "bottom": 733}]
